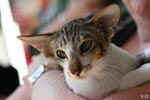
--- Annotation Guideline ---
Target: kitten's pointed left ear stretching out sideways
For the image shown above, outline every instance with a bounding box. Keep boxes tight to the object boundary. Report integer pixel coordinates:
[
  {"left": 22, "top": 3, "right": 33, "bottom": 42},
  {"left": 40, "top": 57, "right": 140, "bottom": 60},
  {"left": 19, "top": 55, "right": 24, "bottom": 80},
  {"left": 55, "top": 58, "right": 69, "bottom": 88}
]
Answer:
[{"left": 18, "top": 32, "right": 57, "bottom": 57}]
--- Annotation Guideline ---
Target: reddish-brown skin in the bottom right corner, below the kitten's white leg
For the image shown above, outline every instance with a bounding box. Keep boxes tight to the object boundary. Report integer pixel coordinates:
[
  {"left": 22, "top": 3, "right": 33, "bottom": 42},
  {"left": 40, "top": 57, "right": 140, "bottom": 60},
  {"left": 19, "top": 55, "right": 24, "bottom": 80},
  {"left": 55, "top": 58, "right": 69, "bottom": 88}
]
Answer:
[{"left": 103, "top": 82, "right": 150, "bottom": 100}]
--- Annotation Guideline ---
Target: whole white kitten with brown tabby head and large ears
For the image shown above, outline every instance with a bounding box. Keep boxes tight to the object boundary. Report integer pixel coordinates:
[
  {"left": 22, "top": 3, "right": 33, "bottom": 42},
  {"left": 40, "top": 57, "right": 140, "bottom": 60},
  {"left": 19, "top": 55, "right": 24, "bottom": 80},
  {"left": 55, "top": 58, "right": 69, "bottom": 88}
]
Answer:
[{"left": 19, "top": 5, "right": 150, "bottom": 100}]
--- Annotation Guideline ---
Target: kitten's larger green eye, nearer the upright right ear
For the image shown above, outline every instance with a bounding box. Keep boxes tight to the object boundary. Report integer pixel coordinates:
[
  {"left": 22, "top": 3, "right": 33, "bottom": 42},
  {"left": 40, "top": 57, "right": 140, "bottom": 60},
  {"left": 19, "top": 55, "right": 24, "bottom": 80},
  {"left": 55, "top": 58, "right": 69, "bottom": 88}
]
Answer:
[{"left": 80, "top": 40, "right": 93, "bottom": 53}]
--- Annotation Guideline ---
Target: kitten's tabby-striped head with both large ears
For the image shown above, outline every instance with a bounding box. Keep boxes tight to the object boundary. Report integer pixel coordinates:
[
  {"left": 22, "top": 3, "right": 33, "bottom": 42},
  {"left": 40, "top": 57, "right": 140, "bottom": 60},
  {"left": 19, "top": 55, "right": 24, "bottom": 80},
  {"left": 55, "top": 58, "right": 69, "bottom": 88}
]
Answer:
[{"left": 19, "top": 5, "right": 120, "bottom": 77}]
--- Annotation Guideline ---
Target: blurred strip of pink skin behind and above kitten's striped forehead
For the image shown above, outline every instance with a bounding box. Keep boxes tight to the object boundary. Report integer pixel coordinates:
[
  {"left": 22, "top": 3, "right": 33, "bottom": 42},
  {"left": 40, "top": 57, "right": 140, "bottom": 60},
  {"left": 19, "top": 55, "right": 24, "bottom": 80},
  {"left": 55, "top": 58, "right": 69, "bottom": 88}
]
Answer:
[{"left": 42, "top": 0, "right": 105, "bottom": 33}]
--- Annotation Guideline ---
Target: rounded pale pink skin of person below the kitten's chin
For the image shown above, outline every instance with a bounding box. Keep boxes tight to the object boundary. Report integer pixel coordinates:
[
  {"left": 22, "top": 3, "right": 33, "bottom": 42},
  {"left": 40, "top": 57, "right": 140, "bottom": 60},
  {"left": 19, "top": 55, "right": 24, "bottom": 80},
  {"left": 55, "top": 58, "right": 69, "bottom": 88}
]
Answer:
[{"left": 32, "top": 71, "right": 87, "bottom": 100}]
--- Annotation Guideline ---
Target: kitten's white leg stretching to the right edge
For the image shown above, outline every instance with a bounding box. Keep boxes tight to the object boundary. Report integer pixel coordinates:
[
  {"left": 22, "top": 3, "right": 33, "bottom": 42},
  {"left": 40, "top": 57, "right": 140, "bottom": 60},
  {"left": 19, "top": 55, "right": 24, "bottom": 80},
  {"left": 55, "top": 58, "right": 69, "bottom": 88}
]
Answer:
[{"left": 120, "top": 63, "right": 150, "bottom": 89}]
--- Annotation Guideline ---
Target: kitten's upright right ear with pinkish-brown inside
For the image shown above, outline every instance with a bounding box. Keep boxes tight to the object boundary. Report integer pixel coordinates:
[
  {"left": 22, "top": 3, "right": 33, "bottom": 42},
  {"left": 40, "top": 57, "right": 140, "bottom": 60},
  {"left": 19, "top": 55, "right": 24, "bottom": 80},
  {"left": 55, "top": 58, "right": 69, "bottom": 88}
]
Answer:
[{"left": 88, "top": 4, "right": 120, "bottom": 38}]
